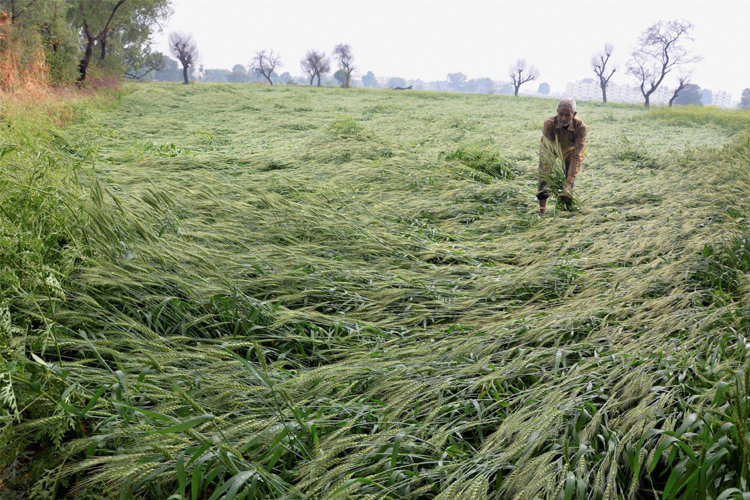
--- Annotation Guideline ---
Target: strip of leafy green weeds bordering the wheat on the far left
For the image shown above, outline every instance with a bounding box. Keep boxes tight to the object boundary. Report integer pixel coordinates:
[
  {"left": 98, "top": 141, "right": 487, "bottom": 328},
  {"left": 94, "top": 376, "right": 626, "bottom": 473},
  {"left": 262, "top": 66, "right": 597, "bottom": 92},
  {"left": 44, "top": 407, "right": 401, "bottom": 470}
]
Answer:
[{"left": 0, "top": 93, "right": 109, "bottom": 498}]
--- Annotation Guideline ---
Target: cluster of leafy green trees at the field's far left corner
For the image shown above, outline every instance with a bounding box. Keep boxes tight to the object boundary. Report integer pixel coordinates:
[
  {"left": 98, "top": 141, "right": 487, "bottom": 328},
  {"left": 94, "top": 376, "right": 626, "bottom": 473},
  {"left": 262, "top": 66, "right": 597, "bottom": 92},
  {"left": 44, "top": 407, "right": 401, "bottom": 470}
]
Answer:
[{"left": 0, "top": 0, "right": 172, "bottom": 83}]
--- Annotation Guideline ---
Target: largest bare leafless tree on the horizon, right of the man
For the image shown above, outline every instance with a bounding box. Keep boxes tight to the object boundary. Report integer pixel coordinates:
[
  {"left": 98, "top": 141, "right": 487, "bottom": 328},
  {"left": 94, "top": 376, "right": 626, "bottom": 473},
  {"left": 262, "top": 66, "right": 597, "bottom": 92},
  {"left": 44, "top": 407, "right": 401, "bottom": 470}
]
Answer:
[{"left": 628, "top": 21, "right": 703, "bottom": 107}]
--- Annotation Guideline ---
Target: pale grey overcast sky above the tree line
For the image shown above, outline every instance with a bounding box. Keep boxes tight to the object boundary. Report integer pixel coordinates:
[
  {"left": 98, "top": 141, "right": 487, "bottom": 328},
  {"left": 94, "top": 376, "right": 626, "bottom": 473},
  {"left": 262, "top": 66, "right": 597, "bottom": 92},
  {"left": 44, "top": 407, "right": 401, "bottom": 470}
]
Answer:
[{"left": 155, "top": 0, "right": 750, "bottom": 100}]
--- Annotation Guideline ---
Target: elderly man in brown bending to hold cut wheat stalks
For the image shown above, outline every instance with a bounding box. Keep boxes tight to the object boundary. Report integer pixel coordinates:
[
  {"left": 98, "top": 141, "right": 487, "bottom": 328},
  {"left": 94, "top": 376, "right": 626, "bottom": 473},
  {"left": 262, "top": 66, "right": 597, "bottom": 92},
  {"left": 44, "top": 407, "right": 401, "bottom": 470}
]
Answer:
[{"left": 536, "top": 99, "right": 587, "bottom": 215}]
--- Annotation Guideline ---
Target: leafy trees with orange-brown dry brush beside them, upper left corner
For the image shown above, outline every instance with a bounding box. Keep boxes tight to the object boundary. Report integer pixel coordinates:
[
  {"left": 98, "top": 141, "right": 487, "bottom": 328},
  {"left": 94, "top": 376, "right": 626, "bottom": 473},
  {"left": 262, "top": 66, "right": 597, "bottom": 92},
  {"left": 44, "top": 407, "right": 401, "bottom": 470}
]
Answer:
[{"left": 0, "top": 0, "right": 172, "bottom": 86}]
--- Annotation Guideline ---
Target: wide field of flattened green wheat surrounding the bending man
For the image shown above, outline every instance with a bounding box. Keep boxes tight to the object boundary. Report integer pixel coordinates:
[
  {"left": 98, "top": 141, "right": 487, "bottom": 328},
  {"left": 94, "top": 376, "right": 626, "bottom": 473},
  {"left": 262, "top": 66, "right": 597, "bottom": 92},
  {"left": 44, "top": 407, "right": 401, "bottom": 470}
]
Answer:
[{"left": 0, "top": 85, "right": 750, "bottom": 500}]
